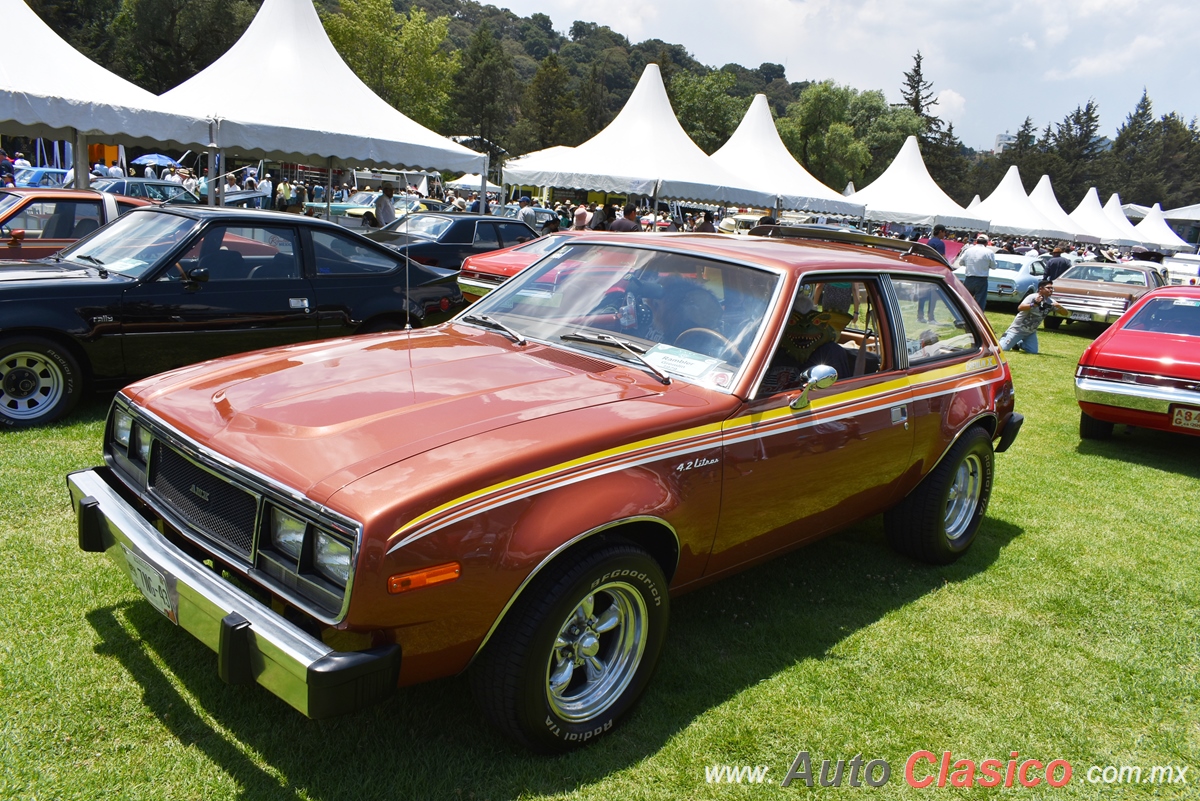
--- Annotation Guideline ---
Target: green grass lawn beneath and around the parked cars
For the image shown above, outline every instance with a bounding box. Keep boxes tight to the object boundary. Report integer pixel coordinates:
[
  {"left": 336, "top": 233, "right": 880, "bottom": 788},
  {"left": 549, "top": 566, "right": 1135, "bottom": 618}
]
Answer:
[{"left": 0, "top": 307, "right": 1200, "bottom": 801}]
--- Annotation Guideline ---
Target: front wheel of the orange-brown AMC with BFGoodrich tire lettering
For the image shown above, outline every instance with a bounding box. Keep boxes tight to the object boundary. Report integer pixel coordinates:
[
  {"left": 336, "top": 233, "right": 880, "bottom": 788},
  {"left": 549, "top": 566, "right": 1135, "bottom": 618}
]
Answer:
[{"left": 472, "top": 542, "right": 670, "bottom": 753}]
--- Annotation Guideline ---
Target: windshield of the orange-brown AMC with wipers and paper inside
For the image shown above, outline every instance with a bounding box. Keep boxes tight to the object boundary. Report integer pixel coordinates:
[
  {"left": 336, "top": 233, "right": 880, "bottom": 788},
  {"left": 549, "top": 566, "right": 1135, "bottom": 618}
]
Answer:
[{"left": 467, "top": 244, "right": 780, "bottom": 392}]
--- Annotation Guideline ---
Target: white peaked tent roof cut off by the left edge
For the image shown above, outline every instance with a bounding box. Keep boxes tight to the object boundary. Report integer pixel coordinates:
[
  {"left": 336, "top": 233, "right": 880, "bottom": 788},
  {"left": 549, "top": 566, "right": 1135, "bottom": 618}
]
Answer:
[{"left": 0, "top": 0, "right": 209, "bottom": 144}]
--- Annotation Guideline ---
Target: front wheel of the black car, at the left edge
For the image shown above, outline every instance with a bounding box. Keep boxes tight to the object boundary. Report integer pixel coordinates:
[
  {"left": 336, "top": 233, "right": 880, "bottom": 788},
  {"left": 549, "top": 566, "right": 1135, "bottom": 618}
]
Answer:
[{"left": 0, "top": 336, "right": 83, "bottom": 428}]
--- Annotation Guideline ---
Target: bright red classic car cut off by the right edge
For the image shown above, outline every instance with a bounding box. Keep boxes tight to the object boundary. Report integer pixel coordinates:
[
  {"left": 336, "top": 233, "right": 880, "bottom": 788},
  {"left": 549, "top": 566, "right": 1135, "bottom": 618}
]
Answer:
[{"left": 1075, "top": 287, "right": 1200, "bottom": 439}]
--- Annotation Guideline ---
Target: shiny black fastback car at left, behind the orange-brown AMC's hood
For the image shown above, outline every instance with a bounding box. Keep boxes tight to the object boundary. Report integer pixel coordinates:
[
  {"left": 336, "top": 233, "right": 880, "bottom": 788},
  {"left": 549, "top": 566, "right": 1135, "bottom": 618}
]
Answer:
[{"left": 0, "top": 205, "right": 464, "bottom": 428}]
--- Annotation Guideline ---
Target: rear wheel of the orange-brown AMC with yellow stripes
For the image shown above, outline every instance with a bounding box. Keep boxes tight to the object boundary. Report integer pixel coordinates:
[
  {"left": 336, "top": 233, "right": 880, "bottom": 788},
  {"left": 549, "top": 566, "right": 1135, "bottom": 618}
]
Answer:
[{"left": 883, "top": 426, "right": 994, "bottom": 565}]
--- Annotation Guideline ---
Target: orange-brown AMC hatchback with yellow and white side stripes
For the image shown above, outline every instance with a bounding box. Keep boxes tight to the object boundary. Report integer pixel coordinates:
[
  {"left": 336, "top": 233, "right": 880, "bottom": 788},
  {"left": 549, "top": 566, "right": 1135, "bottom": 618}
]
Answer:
[{"left": 68, "top": 227, "right": 1022, "bottom": 752}]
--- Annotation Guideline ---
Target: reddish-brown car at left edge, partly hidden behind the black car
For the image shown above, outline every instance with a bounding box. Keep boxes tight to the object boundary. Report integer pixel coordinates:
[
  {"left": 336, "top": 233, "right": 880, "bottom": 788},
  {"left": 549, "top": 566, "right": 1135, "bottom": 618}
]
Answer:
[{"left": 0, "top": 187, "right": 150, "bottom": 260}]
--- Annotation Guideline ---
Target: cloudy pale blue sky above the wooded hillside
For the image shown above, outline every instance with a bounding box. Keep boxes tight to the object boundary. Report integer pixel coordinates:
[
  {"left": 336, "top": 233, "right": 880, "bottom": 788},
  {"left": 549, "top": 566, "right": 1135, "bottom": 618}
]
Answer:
[{"left": 485, "top": 0, "right": 1200, "bottom": 150}]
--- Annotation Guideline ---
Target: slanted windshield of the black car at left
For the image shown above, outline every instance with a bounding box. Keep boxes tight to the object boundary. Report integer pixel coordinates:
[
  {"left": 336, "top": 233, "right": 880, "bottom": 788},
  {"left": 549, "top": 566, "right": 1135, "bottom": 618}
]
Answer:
[{"left": 60, "top": 211, "right": 199, "bottom": 278}]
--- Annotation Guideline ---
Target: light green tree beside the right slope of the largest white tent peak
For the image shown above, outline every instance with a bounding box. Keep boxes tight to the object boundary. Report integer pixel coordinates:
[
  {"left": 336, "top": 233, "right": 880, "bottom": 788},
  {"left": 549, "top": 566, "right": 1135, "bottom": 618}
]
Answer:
[{"left": 322, "top": 0, "right": 458, "bottom": 128}]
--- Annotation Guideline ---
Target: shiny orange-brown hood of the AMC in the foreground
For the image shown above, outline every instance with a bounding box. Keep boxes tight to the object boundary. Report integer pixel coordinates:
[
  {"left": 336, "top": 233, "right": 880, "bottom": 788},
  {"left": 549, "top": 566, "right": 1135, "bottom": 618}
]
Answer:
[{"left": 125, "top": 326, "right": 656, "bottom": 502}]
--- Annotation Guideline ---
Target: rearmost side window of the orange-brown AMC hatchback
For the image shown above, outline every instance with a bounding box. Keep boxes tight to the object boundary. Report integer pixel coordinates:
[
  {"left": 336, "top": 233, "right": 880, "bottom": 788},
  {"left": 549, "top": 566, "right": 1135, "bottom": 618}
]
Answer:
[{"left": 892, "top": 276, "right": 982, "bottom": 367}]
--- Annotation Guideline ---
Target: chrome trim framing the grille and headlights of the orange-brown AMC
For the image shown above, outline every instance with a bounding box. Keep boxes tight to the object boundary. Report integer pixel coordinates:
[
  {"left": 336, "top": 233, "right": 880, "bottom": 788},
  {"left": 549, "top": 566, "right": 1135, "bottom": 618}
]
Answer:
[{"left": 106, "top": 393, "right": 362, "bottom": 625}]
